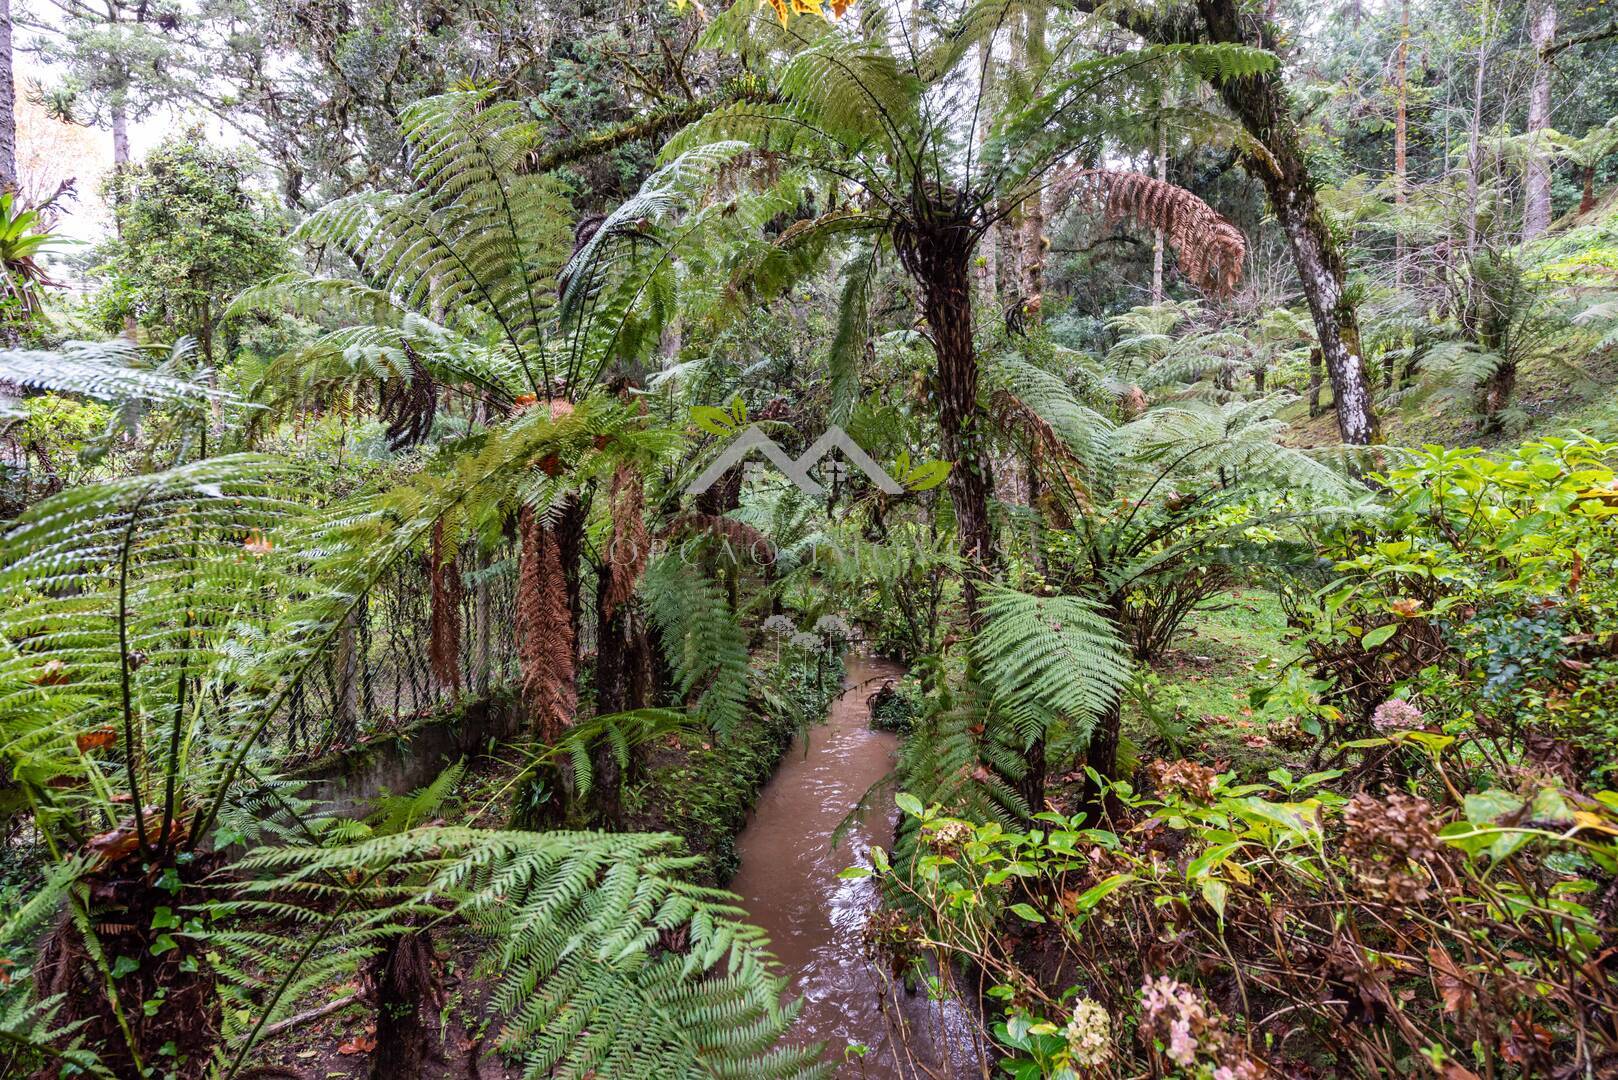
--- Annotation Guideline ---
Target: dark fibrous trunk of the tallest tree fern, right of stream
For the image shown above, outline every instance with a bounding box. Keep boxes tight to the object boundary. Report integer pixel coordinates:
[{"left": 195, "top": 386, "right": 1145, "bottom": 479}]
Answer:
[{"left": 895, "top": 220, "right": 992, "bottom": 628}]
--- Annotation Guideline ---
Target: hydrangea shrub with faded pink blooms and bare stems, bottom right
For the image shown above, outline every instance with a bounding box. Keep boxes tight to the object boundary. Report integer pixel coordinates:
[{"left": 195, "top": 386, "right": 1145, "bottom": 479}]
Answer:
[{"left": 873, "top": 757, "right": 1618, "bottom": 1080}]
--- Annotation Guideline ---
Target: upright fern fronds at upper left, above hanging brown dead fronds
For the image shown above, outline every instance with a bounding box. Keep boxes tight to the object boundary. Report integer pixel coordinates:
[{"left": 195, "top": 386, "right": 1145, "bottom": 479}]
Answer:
[{"left": 235, "top": 89, "right": 579, "bottom": 409}]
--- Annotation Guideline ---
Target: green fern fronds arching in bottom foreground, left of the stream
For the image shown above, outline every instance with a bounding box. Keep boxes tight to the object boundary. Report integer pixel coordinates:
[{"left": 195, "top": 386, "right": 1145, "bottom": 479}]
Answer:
[{"left": 220, "top": 827, "right": 827, "bottom": 1078}]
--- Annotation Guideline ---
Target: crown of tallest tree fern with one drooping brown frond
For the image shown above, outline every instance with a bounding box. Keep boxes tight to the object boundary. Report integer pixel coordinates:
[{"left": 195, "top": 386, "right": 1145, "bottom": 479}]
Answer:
[{"left": 637, "top": 0, "right": 1272, "bottom": 299}]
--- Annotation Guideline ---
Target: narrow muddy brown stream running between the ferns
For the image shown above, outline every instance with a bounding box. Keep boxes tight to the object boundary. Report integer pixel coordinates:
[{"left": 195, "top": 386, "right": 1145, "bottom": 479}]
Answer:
[{"left": 730, "top": 656, "right": 979, "bottom": 1080}]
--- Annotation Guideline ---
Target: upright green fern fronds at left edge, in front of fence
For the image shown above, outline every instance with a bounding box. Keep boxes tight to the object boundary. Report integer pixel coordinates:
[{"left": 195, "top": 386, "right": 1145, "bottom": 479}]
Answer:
[{"left": 0, "top": 455, "right": 303, "bottom": 848}]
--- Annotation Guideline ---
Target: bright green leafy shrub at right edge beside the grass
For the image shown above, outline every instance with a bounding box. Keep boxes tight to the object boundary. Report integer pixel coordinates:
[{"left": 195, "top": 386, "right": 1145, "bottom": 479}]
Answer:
[{"left": 1293, "top": 437, "right": 1618, "bottom": 780}]
